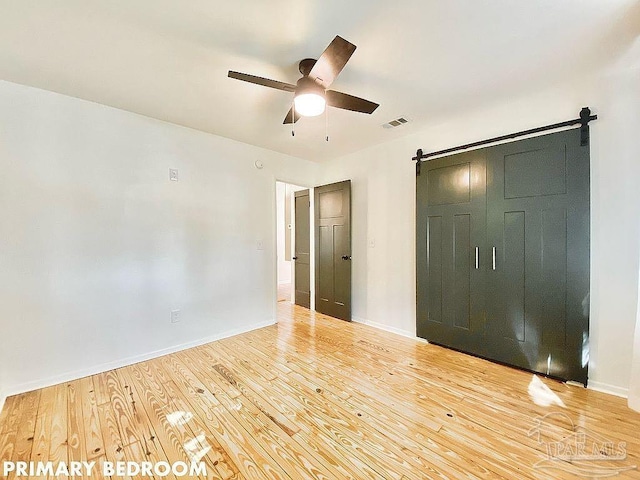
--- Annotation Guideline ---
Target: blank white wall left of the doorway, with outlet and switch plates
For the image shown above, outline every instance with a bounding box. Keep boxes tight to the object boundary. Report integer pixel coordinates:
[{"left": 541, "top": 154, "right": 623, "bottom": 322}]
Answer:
[{"left": 0, "top": 82, "right": 318, "bottom": 402}]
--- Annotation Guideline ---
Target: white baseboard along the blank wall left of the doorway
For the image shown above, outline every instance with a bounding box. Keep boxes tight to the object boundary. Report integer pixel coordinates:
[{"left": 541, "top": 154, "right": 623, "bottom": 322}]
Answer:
[{"left": 0, "top": 320, "right": 276, "bottom": 398}]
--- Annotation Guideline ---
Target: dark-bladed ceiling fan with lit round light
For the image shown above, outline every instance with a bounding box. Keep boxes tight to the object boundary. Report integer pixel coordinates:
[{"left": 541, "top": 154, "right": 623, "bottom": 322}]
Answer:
[{"left": 229, "top": 36, "right": 379, "bottom": 124}]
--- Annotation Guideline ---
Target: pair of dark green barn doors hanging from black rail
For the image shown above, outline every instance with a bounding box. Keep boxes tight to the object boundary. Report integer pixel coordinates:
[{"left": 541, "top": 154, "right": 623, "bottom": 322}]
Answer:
[{"left": 416, "top": 129, "right": 589, "bottom": 383}]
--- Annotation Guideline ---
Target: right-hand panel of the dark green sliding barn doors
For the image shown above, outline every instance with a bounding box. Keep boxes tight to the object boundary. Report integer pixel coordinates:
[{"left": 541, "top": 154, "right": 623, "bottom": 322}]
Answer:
[{"left": 486, "top": 129, "right": 589, "bottom": 383}]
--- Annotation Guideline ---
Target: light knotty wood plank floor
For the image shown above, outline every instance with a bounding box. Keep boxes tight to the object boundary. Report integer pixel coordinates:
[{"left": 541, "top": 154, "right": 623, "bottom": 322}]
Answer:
[{"left": 0, "top": 302, "right": 640, "bottom": 480}]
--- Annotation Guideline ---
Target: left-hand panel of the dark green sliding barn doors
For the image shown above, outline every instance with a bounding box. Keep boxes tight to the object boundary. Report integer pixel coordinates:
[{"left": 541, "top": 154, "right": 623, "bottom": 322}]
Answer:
[{"left": 417, "top": 151, "right": 486, "bottom": 351}]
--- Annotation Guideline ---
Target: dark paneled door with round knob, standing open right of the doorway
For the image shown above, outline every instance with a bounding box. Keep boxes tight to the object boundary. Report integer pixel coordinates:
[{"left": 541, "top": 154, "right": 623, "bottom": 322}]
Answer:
[{"left": 314, "top": 180, "right": 351, "bottom": 320}]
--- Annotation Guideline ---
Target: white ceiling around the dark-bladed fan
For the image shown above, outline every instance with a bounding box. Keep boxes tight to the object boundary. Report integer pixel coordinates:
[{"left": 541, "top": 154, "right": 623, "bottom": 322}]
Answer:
[{"left": 0, "top": 0, "right": 639, "bottom": 161}]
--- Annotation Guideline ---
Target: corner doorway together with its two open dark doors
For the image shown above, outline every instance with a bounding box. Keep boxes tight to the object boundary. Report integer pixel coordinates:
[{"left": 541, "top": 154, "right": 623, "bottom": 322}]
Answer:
[{"left": 276, "top": 180, "right": 351, "bottom": 321}]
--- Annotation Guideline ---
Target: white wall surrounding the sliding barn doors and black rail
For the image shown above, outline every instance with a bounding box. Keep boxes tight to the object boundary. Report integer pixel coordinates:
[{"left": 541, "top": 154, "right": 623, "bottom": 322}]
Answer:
[{"left": 321, "top": 62, "right": 640, "bottom": 395}]
